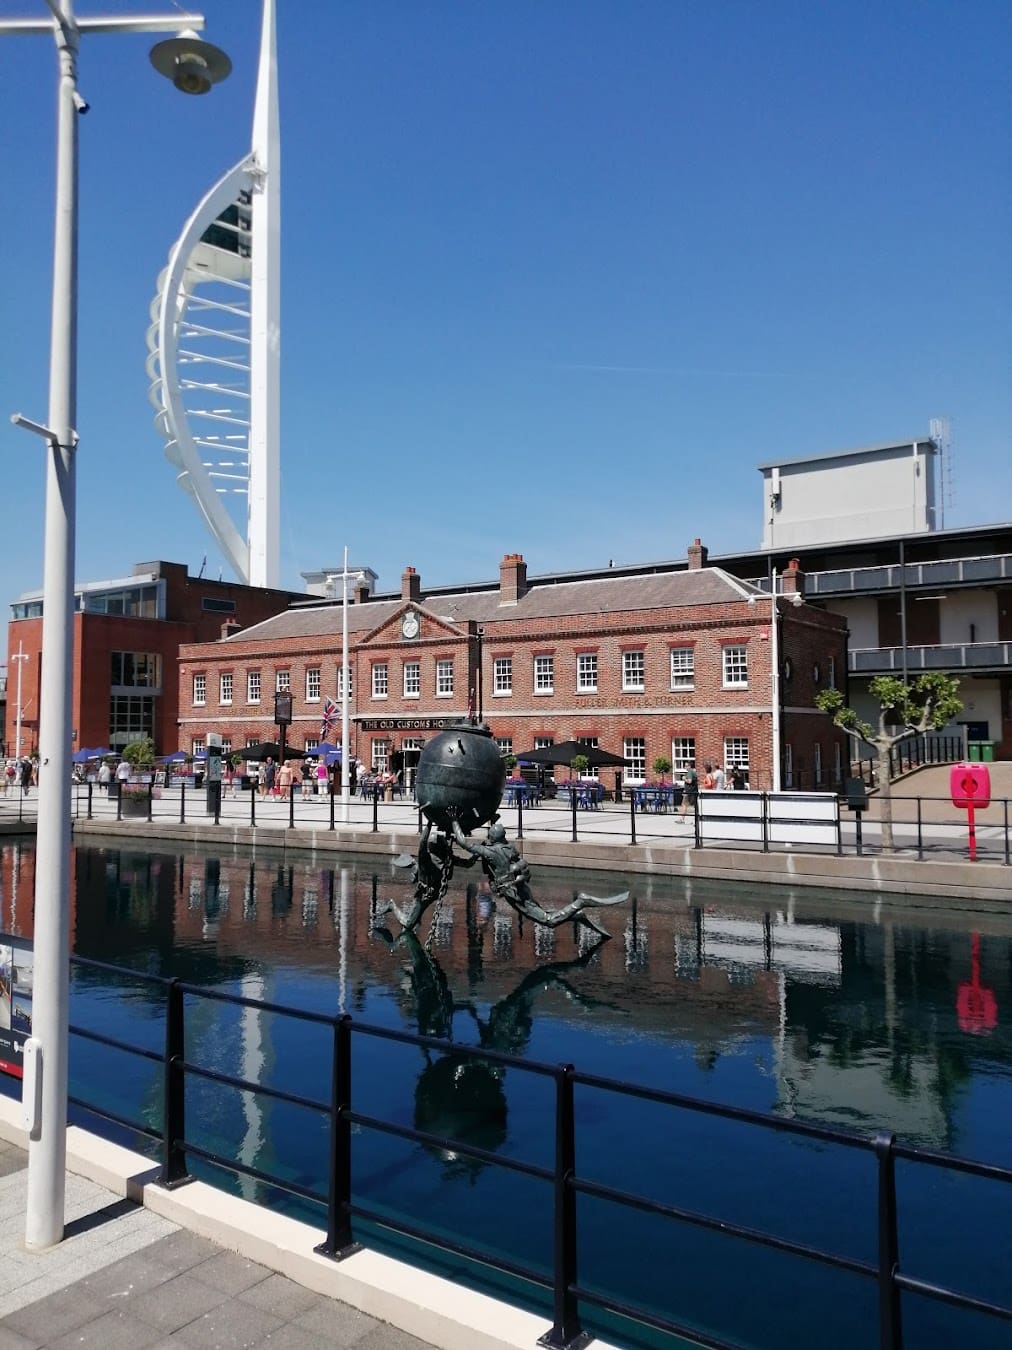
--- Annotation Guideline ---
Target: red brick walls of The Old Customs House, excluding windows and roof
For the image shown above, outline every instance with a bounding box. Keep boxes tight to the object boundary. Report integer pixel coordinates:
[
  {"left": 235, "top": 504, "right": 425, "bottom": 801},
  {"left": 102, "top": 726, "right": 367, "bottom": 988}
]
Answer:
[{"left": 179, "top": 601, "right": 846, "bottom": 787}]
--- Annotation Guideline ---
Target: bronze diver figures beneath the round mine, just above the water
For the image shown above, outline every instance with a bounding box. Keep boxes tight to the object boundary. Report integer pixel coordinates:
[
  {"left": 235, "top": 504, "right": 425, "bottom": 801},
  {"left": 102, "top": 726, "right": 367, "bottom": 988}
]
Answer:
[{"left": 375, "top": 821, "right": 629, "bottom": 941}]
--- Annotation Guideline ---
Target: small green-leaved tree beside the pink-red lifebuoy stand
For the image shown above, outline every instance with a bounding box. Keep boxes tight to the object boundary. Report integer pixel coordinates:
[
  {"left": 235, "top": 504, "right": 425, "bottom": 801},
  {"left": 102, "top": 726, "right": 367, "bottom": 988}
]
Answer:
[{"left": 815, "top": 672, "right": 963, "bottom": 849}]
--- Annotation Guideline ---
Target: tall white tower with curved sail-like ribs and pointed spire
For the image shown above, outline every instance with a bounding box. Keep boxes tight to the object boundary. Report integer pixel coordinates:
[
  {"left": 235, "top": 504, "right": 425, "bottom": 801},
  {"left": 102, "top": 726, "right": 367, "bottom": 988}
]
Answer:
[{"left": 147, "top": 0, "right": 281, "bottom": 587}]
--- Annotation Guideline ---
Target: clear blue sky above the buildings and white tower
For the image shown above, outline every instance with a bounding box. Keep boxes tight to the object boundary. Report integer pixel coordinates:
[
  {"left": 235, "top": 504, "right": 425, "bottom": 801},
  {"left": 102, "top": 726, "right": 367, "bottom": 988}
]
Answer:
[{"left": 0, "top": 0, "right": 1012, "bottom": 603}]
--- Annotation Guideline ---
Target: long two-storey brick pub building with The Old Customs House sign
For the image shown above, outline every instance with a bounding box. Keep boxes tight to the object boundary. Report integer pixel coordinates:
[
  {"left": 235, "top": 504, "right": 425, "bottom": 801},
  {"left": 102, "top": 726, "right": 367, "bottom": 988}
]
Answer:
[{"left": 178, "top": 540, "right": 847, "bottom": 788}]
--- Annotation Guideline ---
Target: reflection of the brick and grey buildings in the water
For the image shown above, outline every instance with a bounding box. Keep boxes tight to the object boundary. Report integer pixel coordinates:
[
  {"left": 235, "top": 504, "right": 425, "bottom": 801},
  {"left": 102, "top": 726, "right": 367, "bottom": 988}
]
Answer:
[{"left": 55, "top": 848, "right": 1012, "bottom": 1142}]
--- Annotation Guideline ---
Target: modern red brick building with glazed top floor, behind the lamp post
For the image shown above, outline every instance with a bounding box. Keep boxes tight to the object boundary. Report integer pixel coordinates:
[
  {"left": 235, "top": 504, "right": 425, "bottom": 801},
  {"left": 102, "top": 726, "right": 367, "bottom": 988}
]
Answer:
[{"left": 3, "top": 562, "right": 302, "bottom": 755}]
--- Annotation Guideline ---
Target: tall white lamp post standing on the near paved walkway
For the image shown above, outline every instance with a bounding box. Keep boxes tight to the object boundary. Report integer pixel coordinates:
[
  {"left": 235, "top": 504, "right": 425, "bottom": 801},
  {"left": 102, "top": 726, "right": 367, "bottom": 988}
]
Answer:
[{"left": 0, "top": 0, "right": 232, "bottom": 1249}]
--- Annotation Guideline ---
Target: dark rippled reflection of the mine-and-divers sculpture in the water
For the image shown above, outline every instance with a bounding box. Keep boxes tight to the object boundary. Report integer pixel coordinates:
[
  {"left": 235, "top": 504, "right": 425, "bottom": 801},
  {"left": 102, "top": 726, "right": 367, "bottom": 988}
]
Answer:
[{"left": 375, "top": 923, "right": 617, "bottom": 1181}]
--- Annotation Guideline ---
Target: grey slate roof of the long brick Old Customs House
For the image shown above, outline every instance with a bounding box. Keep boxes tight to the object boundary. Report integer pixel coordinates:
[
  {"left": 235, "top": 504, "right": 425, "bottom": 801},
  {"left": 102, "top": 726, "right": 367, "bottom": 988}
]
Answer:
[{"left": 223, "top": 567, "right": 764, "bottom": 643}]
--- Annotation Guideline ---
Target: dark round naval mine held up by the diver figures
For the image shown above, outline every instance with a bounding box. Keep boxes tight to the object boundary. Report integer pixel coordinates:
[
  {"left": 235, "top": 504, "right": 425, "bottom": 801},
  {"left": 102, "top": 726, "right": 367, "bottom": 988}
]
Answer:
[{"left": 414, "top": 722, "right": 506, "bottom": 834}]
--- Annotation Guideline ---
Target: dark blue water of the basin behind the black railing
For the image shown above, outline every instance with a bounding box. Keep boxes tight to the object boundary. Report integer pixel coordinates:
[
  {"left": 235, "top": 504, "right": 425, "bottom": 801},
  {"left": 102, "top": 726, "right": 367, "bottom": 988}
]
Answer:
[{"left": 3, "top": 848, "right": 1012, "bottom": 1347}]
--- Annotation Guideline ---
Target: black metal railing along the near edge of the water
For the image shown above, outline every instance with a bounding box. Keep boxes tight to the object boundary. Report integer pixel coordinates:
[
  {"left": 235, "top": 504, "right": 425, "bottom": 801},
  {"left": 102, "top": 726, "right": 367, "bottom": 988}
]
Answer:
[{"left": 70, "top": 957, "right": 1012, "bottom": 1350}]
